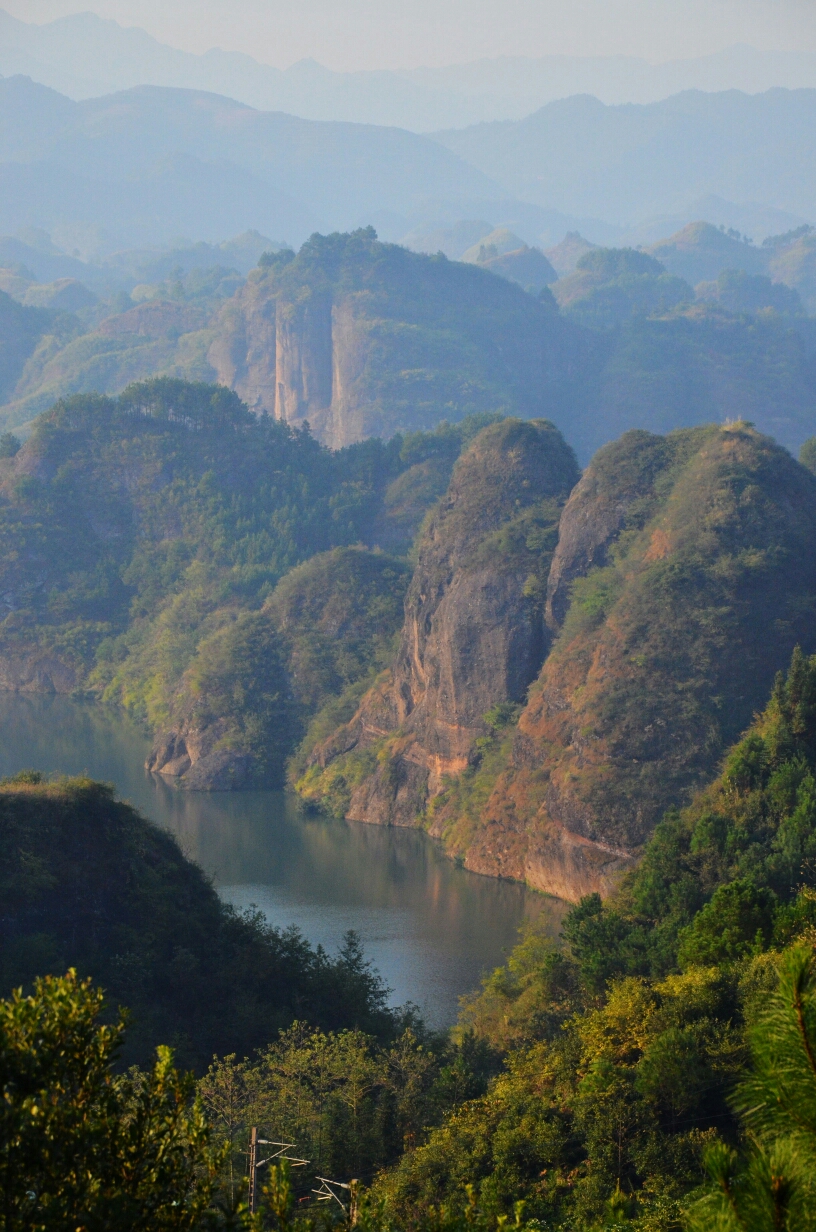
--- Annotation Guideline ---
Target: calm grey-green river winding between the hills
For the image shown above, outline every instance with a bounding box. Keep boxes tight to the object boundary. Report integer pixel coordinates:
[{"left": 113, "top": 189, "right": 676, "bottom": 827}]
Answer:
[{"left": 0, "top": 692, "right": 565, "bottom": 1026}]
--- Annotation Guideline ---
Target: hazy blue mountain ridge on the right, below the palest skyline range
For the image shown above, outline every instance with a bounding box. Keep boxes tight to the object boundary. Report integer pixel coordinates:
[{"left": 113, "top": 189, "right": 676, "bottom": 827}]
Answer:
[{"left": 435, "top": 89, "right": 816, "bottom": 227}]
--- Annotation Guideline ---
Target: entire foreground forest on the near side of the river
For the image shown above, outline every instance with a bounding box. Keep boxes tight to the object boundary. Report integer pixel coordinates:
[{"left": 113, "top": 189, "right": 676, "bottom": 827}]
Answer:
[{"left": 8, "top": 650, "right": 816, "bottom": 1232}]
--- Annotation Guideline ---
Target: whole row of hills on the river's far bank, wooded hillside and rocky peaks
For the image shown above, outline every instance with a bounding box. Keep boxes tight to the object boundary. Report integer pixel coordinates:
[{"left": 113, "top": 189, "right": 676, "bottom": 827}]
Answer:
[{"left": 0, "top": 378, "right": 816, "bottom": 898}]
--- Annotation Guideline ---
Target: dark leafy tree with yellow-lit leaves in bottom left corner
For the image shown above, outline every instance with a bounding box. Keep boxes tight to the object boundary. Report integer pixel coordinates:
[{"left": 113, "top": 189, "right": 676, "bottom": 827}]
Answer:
[{"left": 0, "top": 971, "right": 221, "bottom": 1232}]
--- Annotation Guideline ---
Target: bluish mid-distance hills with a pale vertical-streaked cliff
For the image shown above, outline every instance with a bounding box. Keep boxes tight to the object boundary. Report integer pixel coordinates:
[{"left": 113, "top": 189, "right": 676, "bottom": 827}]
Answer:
[{"left": 6, "top": 228, "right": 816, "bottom": 464}]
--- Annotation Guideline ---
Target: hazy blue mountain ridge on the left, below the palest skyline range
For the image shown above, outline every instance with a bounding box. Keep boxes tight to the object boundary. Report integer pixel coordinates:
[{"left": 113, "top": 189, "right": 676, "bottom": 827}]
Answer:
[{"left": 0, "top": 76, "right": 502, "bottom": 251}]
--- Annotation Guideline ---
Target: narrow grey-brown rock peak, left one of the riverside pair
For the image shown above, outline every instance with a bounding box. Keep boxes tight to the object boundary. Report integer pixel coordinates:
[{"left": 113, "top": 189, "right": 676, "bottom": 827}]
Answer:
[{"left": 305, "top": 420, "right": 577, "bottom": 825}]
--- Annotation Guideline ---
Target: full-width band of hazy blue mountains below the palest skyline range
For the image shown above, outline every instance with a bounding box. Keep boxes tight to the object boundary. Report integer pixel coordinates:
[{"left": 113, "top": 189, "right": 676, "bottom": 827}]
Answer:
[{"left": 0, "top": 76, "right": 816, "bottom": 253}]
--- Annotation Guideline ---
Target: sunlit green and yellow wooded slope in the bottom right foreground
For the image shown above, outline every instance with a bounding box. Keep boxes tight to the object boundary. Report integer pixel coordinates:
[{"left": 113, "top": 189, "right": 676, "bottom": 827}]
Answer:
[{"left": 377, "top": 652, "right": 816, "bottom": 1230}]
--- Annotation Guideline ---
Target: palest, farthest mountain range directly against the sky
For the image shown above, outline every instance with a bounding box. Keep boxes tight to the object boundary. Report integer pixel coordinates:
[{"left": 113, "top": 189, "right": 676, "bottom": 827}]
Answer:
[{"left": 0, "top": 11, "right": 816, "bottom": 132}]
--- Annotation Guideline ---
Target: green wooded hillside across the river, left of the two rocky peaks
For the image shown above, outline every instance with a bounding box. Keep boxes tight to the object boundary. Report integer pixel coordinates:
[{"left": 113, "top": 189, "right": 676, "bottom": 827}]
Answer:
[{"left": 0, "top": 378, "right": 497, "bottom": 781}]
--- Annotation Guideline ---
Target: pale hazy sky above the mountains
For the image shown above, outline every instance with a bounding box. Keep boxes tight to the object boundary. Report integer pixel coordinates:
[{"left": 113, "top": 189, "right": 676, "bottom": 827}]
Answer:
[{"left": 6, "top": 0, "right": 816, "bottom": 69}]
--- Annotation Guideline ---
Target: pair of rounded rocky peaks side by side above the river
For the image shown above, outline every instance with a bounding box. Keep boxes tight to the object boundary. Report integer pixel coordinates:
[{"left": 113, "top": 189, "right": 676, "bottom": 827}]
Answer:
[{"left": 306, "top": 424, "right": 816, "bottom": 898}]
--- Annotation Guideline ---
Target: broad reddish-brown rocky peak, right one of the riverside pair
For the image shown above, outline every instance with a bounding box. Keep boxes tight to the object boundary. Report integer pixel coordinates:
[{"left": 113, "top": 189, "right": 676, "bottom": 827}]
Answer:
[{"left": 454, "top": 425, "right": 816, "bottom": 899}]
